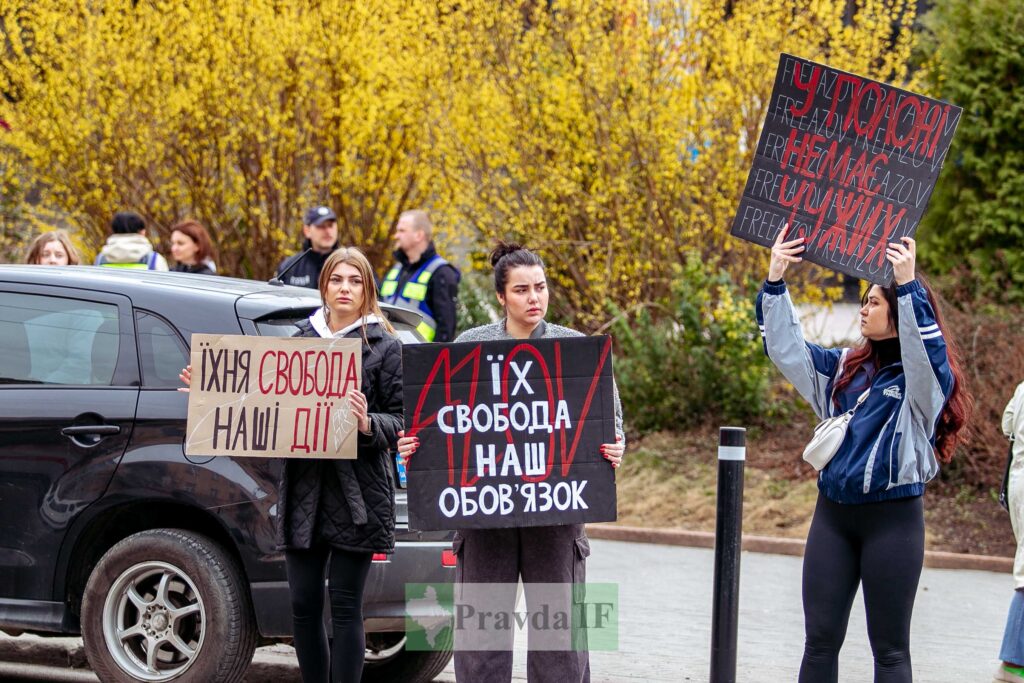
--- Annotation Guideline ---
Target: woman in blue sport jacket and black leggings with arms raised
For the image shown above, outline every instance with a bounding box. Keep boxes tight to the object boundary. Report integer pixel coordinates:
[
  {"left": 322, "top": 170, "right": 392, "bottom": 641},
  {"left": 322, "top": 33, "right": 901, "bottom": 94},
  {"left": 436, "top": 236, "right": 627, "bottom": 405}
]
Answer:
[{"left": 757, "top": 226, "right": 972, "bottom": 683}]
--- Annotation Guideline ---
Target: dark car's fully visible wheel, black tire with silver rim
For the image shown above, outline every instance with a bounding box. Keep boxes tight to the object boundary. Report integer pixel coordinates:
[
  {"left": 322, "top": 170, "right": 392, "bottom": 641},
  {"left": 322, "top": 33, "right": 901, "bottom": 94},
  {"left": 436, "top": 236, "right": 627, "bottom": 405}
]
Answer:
[{"left": 82, "top": 528, "right": 257, "bottom": 683}]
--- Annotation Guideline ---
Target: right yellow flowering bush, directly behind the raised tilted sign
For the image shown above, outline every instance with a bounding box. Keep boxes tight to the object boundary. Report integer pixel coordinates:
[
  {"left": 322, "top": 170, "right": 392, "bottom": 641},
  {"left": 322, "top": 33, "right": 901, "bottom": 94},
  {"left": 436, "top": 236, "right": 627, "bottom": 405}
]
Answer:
[{"left": 437, "top": 0, "right": 913, "bottom": 329}]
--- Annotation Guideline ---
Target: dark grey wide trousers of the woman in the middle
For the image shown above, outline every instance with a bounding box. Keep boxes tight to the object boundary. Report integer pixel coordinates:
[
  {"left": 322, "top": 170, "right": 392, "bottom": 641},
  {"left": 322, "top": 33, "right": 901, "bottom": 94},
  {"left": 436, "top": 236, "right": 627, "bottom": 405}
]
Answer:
[{"left": 454, "top": 524, "right": 590, "bottom": 683}]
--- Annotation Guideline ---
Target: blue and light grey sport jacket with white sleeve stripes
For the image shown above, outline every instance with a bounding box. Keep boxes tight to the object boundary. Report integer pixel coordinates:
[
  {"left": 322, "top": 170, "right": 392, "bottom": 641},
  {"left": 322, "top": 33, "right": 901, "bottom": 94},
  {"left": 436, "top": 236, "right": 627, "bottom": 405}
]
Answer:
[{"left": 757, "top": 281, "right": 953, "bottom": 503}]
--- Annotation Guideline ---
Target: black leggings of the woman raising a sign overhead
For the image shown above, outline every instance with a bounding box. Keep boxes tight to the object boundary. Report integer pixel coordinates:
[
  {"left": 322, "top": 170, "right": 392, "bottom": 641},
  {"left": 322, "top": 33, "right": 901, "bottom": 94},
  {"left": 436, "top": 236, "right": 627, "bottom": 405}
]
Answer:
[{"left": 800, "top": 495, "right": 925, "bottom": 683}]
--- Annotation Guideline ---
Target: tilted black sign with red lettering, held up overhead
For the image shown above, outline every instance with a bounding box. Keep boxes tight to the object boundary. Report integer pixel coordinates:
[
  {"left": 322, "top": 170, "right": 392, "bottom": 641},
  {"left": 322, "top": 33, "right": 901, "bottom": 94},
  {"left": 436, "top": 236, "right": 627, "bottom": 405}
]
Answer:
[{"left": 732, "top": 54, "right": 962, "bottom": 285}]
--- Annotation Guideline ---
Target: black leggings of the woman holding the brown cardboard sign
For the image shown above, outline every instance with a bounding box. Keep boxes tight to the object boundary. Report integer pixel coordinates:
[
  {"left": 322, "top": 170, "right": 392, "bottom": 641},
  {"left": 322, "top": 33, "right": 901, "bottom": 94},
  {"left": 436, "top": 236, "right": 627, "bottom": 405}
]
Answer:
[{"left": 285, "top": 545, "right": 373, "bottom": 683}]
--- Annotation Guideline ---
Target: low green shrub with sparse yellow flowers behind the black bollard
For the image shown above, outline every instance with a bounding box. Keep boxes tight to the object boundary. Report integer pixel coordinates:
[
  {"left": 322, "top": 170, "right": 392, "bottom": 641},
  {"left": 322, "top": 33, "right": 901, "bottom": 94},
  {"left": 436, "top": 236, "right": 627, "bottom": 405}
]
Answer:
[{"left": 611, "top": 255, "right": 773, "bottom": 433}]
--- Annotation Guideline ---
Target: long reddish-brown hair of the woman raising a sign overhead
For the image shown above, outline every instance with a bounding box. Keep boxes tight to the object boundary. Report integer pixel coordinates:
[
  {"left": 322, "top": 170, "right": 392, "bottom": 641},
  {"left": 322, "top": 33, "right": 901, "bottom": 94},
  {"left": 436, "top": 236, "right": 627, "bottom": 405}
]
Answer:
[{"left": 833, "top": 274, "right": 974, "bottom": 463}]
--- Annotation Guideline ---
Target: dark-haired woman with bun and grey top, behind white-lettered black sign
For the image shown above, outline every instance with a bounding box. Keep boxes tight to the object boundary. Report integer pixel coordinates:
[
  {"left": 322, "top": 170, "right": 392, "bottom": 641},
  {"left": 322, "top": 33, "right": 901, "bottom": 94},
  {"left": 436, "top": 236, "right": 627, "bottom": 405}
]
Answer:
[{"left": 398, "top": 243, "right": 625, "bottom": 683}]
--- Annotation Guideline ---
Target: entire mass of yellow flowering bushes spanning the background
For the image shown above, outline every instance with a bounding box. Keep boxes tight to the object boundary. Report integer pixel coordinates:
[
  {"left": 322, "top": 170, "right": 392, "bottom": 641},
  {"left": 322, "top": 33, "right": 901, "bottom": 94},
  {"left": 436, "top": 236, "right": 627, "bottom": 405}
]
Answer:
[{"left": 0, "top": 0, "right": 913, "bottom": 315}]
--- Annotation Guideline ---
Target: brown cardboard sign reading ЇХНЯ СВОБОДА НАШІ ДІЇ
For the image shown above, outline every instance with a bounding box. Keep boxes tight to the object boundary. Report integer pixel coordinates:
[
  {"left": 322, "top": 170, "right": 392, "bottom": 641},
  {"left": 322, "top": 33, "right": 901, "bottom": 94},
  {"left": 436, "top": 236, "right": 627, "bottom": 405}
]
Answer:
[{"left": 185, "top": 335, "right": 362, "bottom": 459}]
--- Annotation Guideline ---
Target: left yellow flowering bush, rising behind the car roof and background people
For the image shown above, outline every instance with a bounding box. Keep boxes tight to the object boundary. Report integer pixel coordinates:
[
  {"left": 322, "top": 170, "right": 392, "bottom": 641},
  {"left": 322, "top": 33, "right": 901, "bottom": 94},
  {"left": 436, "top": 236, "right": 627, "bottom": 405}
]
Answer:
[{"left": 0, "top": 0, "right": 440, "bottom": 278}]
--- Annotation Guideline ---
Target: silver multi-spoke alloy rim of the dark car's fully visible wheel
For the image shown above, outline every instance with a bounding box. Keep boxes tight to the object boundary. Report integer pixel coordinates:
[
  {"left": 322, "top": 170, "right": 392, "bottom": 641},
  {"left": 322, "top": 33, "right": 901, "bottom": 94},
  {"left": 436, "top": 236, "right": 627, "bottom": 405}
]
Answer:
[{"left": 102, "top": 561, "right": 207, "bottom": 682}]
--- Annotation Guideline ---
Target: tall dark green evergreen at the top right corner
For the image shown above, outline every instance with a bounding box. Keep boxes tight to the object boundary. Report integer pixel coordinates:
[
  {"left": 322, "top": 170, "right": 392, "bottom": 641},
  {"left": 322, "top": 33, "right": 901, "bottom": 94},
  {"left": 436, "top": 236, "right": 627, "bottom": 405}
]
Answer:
[{"left": 918, "top": 0, "right": 1024, "bottom": 303}]
